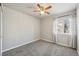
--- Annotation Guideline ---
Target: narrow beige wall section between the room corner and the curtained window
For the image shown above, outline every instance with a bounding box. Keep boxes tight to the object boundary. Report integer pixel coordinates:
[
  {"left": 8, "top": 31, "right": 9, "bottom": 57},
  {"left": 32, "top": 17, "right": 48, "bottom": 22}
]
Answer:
[{"left": 40, "top": 17, "right": 53, "bottom": 42}]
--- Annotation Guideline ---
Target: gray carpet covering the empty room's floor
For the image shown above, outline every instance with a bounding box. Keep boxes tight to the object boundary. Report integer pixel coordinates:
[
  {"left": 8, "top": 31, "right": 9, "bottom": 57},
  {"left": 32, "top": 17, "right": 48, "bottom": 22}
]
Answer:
[{"left": 2, "top": 40, "right": 78, "bottom": 56}]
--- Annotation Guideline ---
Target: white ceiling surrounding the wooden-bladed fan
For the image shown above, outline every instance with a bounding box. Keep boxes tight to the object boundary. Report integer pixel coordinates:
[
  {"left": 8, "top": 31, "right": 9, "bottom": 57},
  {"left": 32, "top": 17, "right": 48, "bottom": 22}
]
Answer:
[{"left": 4, "top": 3, "right": 77, "bottom": 18}]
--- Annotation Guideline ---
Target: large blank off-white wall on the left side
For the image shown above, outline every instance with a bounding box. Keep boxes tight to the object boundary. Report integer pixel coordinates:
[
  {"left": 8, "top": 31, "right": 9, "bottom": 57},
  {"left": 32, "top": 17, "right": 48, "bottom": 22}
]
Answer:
[{"left": 2, "top": 7, "right": 40, "bottom": 51}]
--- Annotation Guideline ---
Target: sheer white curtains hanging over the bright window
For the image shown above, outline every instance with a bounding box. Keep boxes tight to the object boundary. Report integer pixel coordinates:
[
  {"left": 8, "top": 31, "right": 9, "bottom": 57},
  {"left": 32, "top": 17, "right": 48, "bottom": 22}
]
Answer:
[{"left": 53, "top": 14, "right": 76, "bottom": 48}]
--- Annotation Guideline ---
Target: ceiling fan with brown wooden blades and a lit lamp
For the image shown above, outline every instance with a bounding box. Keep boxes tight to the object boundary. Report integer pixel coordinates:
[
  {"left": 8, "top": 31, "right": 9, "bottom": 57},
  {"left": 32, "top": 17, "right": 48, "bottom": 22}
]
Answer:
[{"left": 34, "top": 4, "right": 52, "bottom": 15}]
